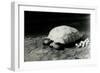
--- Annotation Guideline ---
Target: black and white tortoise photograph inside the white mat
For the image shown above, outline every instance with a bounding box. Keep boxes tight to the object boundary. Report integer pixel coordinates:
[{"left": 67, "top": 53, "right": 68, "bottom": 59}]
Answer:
[{"left": 24, "top": 10, "right": 91, "bottom": 62}]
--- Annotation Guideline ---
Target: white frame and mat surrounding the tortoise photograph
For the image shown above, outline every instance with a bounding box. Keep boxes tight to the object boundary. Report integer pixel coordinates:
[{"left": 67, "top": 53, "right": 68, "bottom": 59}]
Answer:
[{"left": 11, "top": 2, "right": 97, "bottom": 71}]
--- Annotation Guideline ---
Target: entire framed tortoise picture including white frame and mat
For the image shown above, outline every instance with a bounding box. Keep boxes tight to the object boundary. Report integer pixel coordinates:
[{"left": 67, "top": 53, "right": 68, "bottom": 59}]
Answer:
[{"left": 11, "top": 2, "right": 99, "bottom": 71}]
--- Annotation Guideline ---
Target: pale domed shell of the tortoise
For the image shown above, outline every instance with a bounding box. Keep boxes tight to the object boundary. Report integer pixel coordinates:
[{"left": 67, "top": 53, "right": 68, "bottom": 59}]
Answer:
[{"left": 48, "top": 25, "right": 81, "bottom": 44}]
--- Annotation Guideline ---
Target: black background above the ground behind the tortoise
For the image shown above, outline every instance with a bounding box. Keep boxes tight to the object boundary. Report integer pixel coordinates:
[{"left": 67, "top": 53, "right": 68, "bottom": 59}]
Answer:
[{"left": 24, "top": 11, "right": 90, "bottom": 36}]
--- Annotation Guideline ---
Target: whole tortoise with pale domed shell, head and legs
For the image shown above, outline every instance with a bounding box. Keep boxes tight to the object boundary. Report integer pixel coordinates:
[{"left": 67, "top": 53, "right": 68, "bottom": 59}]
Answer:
[{"left": 43, "top": 25, "right": 87, "bottom": 49}]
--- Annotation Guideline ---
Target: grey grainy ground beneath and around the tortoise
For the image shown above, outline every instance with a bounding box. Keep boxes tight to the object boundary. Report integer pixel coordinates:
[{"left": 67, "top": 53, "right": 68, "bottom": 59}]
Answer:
[{"left": 24, "top": 36, "right": 90, "bottom": 62}]
